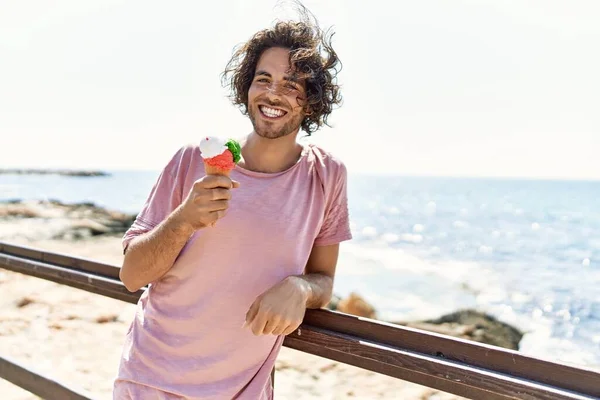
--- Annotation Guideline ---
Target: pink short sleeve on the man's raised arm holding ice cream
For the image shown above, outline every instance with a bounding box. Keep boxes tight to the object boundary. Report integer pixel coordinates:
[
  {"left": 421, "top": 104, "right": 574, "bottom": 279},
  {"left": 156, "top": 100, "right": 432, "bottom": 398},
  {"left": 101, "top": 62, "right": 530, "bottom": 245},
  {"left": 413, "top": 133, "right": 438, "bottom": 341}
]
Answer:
[{"left": 122, "top": 150, "right": 185, "bottom": 252}]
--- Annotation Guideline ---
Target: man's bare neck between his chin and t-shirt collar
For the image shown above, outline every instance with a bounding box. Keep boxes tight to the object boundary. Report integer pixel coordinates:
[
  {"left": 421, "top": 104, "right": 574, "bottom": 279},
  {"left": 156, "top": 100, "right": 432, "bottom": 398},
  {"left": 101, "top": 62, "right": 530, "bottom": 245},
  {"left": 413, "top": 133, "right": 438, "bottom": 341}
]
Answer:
[{"left": 239, "top": 131, "right": 302, "bottom": 173}]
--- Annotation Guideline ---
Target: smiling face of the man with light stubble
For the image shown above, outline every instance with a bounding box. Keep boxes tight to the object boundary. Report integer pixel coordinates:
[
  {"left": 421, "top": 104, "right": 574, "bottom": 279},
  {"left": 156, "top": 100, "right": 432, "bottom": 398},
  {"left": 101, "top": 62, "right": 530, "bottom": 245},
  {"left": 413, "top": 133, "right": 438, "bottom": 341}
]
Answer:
[{"left": 248, "top": 47, "right": 306, "bottom": 139}]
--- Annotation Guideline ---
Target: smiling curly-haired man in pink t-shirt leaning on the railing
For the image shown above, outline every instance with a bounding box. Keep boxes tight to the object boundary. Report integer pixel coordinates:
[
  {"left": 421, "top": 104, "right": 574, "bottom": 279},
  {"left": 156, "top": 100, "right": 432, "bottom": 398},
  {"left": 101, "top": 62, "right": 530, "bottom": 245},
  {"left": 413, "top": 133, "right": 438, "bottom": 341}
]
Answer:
[{"left": 114, "top": 10, "right": 351, "bottom": 400}]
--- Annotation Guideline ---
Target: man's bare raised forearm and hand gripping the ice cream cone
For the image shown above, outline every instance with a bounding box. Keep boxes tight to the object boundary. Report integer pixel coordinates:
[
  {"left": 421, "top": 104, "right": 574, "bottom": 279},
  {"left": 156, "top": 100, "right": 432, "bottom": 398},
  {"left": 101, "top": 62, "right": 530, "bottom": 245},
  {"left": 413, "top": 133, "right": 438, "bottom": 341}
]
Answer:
[{"left": 119, "top": 175, "right": 239, "bottom": 292}]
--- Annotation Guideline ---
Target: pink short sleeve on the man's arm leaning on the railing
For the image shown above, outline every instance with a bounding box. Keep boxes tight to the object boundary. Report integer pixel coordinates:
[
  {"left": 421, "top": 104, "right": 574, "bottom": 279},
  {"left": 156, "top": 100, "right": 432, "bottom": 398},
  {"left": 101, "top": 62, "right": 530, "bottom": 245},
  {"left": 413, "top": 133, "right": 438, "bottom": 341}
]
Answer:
[{"left": 314, "top": 163, "right": 352, "bottom": 246}]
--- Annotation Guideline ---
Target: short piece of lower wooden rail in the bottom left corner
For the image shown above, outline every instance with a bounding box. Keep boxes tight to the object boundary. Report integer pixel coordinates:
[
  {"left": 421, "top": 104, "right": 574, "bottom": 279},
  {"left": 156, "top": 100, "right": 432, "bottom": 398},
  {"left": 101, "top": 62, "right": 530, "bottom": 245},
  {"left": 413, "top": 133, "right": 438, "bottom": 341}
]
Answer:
[{"left": 0, "top": 355, "right": 91, "bottom": 400}]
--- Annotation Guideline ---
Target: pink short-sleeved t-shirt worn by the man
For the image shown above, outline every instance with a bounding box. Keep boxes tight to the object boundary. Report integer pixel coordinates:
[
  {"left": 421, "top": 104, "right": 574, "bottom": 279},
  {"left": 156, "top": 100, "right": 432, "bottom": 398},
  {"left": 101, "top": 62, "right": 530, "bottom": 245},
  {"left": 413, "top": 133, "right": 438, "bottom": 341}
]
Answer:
[{"left": 114, "top": 145, "right": 351, "bottom": 400}]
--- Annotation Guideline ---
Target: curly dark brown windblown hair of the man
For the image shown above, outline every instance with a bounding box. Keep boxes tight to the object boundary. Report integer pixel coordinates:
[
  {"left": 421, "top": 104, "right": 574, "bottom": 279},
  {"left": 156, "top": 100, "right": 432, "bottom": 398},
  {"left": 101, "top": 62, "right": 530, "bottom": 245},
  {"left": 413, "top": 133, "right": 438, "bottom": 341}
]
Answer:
[{"left": 222, "top": 7, "right": 342, "bottom": 136}]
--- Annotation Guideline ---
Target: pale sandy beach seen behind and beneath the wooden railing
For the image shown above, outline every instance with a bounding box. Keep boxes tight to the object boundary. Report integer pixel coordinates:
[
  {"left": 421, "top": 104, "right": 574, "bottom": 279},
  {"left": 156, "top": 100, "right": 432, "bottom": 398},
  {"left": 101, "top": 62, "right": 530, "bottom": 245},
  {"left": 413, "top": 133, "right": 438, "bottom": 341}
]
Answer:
[{"left": 0, "top": 205, "right": 459, "bottom": 400}]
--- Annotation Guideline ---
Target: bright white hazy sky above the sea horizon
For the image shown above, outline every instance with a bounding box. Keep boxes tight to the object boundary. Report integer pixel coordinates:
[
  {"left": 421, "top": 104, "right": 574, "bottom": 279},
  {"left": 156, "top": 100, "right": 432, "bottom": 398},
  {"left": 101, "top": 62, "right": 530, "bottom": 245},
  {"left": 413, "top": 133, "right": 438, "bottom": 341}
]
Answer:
[{"left": 0, "top": 0, "right": 600, "bottom": 179}]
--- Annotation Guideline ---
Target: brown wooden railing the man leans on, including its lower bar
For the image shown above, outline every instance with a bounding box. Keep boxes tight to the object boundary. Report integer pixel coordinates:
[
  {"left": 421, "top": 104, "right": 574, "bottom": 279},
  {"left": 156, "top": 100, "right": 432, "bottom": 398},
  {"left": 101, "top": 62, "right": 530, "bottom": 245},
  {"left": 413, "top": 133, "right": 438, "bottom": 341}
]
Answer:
[{"left": 0, "top": 242, "right": 600, "bottom": 400}]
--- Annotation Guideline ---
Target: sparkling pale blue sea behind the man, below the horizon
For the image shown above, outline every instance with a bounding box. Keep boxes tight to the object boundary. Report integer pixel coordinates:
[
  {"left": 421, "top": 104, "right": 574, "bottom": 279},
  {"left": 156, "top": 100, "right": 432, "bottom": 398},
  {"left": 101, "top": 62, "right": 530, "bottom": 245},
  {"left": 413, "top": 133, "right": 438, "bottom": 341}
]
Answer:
[{"left": 0, "top": 171, "right": 600, "bottom": 369}]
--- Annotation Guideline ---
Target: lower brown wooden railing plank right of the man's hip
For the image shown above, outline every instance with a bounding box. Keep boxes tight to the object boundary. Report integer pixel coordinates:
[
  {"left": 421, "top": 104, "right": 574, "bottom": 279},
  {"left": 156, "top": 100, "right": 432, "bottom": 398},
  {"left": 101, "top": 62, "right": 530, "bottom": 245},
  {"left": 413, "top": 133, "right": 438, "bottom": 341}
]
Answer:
[{"left": 285, "top": 325, "right": 594, "bottom": 400}]
